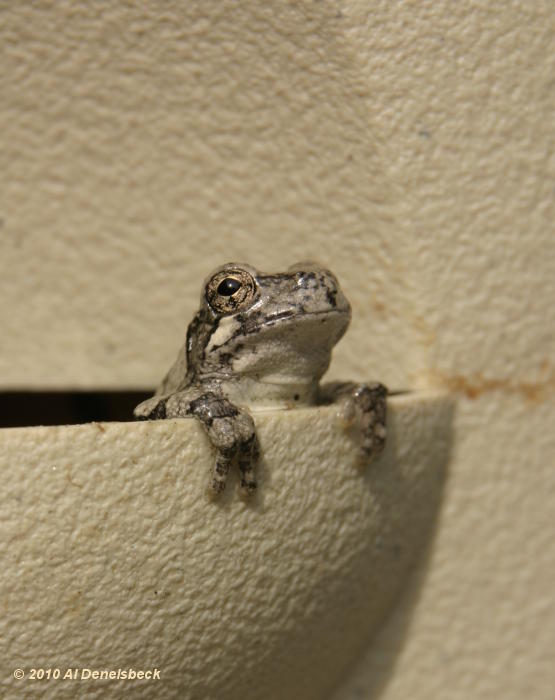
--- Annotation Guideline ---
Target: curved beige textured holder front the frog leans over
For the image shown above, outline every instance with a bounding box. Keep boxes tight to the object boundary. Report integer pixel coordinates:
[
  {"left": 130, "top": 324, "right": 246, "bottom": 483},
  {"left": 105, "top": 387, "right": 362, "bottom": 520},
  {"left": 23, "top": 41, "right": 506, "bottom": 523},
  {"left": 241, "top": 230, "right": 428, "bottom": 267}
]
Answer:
[{"left": 0, "top": 395, "right": 451, "bottom": 700}]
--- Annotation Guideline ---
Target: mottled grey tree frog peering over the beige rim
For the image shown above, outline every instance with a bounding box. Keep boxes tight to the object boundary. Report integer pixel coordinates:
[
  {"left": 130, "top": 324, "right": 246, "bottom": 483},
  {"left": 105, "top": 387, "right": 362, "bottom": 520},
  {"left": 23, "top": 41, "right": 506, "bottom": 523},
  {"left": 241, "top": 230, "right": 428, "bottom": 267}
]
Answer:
[{"left": 134, "top": 262, "right": 388, "bottom": 498}]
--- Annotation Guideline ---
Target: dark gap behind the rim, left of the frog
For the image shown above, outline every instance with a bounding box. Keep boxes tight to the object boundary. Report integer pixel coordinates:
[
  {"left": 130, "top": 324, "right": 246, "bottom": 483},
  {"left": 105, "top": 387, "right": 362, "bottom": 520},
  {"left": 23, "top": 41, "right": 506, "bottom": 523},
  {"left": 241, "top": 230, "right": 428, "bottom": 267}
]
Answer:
[{"left": 0, "top": 391, "right": 152, "bottom": 428}]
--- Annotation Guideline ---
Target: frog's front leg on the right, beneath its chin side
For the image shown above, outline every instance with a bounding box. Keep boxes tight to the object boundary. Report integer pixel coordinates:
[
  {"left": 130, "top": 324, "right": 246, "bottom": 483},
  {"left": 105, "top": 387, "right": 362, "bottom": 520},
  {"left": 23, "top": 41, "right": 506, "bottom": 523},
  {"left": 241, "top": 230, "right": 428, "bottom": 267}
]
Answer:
[{"left": 322, "top": 382, "right": 387, "bottom": 461}]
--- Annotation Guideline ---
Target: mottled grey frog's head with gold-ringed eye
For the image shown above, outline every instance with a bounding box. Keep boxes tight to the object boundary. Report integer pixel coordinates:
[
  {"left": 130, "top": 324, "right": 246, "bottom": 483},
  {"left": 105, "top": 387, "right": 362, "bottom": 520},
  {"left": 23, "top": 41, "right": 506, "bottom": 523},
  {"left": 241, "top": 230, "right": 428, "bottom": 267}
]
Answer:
[{"left": 187, "top": 263, "right": 351, "bottom": 384}]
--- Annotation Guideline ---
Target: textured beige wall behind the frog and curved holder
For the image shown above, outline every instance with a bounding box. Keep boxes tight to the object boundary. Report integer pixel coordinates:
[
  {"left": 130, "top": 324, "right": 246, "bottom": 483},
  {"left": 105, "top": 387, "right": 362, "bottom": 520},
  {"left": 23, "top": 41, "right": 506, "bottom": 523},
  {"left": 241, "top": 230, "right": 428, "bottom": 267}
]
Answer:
[{"left": 0, "top": 0, "right": 555, "bottom": 700}]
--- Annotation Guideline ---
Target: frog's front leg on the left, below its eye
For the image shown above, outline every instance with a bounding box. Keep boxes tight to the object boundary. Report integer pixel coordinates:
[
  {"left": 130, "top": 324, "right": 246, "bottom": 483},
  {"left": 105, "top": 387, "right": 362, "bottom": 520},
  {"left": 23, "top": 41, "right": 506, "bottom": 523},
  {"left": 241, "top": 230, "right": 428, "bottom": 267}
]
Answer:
[{"left": 187, "top": 392, "right": 259, "bottom": 496}]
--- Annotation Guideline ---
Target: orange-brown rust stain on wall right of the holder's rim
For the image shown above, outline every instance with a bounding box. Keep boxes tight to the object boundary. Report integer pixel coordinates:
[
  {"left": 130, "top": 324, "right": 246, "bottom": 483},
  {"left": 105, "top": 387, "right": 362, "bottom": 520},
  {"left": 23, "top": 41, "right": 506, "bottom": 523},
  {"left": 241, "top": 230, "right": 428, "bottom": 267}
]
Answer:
[{"left": 430, "top": 362, "right": 555, "bottom": 404}]
